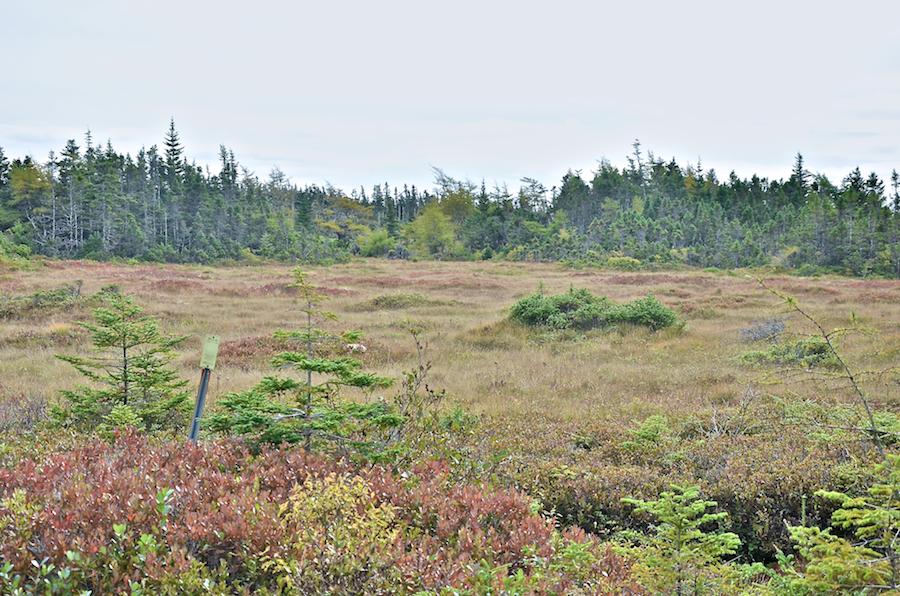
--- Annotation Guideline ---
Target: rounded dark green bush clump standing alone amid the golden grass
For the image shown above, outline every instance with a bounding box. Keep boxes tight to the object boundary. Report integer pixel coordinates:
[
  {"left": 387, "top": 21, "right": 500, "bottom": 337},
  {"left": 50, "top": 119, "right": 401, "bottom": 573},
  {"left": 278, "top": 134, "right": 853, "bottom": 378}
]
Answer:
[{"left": 510, "top": 287, "right": 684, "bottom": 331}]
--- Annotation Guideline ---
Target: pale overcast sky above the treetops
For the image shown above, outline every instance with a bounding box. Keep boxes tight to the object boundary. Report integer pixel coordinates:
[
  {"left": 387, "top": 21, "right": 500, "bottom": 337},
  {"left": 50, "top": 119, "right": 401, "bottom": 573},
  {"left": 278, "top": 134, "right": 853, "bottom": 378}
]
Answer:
[{"left": 0, "top": 0, "right": 900, "bottom": 191}]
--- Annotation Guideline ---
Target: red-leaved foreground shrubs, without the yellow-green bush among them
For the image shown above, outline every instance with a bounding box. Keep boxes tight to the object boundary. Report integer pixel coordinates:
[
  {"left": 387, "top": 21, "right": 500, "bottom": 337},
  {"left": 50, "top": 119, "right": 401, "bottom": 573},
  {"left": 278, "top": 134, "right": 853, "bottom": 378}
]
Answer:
[{"left": 0, "top": 432, "right": 638, "bottom": 593}]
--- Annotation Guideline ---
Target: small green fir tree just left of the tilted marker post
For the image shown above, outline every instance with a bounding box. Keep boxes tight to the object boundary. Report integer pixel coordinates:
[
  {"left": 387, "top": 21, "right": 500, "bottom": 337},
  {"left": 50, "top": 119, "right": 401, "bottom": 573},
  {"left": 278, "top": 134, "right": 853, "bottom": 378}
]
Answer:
[{"left": 53, "top": 292, "right": 190, "bottom": 431}]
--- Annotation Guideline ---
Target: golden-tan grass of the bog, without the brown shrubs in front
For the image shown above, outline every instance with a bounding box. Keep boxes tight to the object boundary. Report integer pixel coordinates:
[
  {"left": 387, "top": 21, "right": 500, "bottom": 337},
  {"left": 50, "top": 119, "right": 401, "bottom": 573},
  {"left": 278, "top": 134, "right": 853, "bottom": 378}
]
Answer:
[{"left": 0, "top": 259, "right": 900, "bottom": 419}]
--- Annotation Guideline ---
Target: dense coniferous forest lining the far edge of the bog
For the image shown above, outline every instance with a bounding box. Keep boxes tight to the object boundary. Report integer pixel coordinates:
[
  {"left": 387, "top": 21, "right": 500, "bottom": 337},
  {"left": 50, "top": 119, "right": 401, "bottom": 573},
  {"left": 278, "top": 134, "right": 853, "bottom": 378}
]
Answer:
[{"left": 0, "top": 121, "right": 900, "bottom": 277}]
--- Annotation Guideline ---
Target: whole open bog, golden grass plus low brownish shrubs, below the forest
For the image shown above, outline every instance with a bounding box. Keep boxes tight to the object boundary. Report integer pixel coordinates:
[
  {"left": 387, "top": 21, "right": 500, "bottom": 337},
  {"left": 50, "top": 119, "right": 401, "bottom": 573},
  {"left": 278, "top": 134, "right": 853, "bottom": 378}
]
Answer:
[{"left": 0, "top": 260, "right": 900, "bottom": 562}]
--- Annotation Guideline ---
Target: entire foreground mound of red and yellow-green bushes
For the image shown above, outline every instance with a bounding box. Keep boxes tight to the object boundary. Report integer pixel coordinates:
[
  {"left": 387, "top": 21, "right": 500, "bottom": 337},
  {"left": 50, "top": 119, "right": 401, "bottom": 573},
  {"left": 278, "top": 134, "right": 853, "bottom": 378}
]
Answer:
[{"left": 0, "top": 432, "right": 642, "bottom": 596}]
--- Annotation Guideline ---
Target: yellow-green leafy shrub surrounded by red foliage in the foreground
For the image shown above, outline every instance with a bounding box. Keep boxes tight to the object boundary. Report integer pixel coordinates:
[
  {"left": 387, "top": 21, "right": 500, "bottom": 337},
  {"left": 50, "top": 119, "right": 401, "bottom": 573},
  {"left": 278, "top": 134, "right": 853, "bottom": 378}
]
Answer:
[{"left": 263, "top": 473, "right": 400, "bottom": 594}]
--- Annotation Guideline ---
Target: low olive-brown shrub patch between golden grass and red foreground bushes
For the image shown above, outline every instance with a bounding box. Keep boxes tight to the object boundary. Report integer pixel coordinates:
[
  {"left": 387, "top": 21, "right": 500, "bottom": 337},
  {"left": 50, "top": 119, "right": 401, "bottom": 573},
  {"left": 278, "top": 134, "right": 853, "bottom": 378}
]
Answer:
[{"left": 429, "top": 412, "right": 874, "bottom": 562}]
